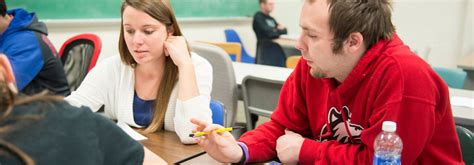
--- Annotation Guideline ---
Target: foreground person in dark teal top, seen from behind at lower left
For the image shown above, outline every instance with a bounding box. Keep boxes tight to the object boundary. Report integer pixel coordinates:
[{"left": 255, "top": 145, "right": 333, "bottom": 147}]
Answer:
[{"left": 0, "top": 54, "right": 166, "bottom": 165}]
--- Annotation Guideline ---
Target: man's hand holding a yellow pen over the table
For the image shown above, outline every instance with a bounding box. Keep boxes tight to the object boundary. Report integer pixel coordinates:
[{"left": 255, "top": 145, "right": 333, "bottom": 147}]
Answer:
[{"left": 191, "top": 119, "right": 244, "bottom": 163}]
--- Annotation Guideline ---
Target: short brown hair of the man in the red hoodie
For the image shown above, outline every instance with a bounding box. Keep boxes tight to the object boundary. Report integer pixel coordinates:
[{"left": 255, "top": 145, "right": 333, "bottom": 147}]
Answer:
[{"left": 309, "top": 0, "right": 395, "bottom": 53}]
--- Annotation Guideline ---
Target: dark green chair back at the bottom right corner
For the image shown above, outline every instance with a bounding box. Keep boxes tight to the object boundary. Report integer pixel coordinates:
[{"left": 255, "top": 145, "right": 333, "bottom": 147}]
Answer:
[{"left": 456, "top": 125, "right": 474, "bottom": 164}]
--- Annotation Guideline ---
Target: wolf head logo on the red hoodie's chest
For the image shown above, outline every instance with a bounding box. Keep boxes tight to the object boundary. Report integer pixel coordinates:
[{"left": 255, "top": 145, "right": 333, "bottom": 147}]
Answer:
[{"left": 319, "top": 106, "right": 364, "bottom": 143}]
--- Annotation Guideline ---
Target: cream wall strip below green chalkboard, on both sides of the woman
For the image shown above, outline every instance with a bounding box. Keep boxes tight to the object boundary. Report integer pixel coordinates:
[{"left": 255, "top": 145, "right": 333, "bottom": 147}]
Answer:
[{"left": 45, "top": 18, "right": 256, "bottom": 61}]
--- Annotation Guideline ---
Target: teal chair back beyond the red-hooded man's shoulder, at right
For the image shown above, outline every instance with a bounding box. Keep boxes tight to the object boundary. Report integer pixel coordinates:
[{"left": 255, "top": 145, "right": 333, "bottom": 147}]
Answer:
[{"left": 433, "top": 67, "right": 467, "bottom": 89}]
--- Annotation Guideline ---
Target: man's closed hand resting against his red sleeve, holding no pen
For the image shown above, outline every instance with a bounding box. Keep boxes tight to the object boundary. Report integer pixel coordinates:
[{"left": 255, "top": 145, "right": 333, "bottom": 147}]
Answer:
[{"left": 276, "top": 129, "right": 304, "bottom": 164}]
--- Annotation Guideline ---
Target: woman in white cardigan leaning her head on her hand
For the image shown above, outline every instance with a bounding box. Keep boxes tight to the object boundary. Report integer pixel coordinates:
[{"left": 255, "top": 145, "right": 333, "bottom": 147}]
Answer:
[{"left": 66, "top": 0, "right": 212, "bottom": 143}]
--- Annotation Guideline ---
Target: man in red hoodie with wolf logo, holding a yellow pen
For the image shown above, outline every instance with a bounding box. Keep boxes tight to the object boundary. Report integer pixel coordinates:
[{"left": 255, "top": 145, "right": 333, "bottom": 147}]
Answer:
[{"left": 192, "top": 0, "right": 463, "bottom": 164}]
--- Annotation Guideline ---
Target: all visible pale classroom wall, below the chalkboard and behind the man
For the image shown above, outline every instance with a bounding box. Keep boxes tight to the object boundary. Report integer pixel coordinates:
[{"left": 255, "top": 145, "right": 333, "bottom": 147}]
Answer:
[{"left": 46, "top": 0, "right": 474, "bottom": 68}]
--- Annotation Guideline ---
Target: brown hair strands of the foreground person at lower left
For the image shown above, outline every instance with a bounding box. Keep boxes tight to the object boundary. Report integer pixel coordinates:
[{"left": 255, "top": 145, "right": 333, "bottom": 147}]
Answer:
[{"left": 0, "top": 81, "right": 63, "bottom": 165}]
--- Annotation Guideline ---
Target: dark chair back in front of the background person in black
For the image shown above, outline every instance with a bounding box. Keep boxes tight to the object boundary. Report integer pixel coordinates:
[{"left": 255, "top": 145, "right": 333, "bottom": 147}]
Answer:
[{"left": 255, "top": 40, "right": 286, "bottom": 67}]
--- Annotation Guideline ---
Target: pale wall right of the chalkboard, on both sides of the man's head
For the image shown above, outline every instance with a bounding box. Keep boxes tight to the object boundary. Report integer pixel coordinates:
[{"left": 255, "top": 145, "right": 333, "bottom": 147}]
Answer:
[{"left": 273, "top": 0, "right": 474, "bottom": 68}]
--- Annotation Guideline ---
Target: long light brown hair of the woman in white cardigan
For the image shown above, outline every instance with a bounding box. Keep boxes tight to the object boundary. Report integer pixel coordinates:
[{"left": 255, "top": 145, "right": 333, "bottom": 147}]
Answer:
[{"left": 119, "top": 0, "right": 189, "bottom": 133}]
